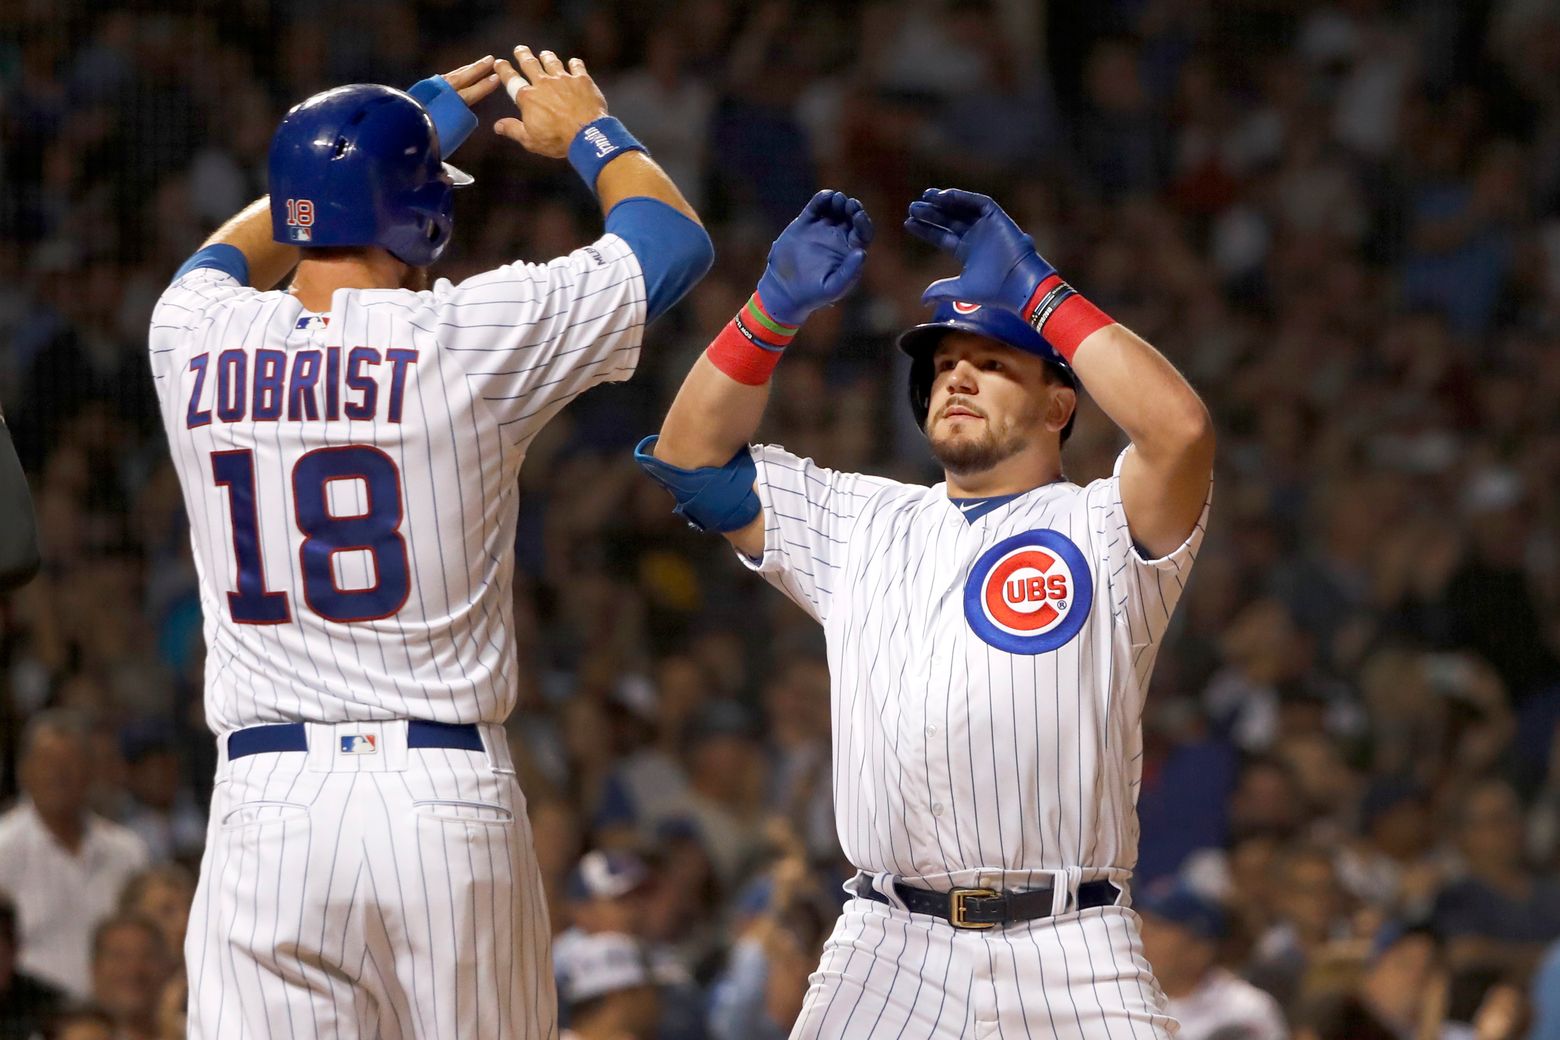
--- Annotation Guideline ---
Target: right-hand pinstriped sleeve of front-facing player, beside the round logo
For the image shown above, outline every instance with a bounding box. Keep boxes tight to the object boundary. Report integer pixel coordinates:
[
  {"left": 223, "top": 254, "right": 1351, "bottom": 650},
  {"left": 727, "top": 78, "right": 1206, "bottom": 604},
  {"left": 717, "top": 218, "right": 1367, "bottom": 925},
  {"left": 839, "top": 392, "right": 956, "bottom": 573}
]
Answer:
[{"left": 1089, "top": 451, "right": 1214, "bottom": 647}]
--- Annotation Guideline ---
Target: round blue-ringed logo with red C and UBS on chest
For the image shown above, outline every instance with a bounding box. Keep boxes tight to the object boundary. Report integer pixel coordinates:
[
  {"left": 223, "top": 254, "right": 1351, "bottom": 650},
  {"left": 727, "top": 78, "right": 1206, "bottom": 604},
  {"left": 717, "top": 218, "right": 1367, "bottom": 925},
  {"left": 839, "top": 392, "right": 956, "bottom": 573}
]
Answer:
[{"left": 964, "top": 530, "right": 1094, "bottom": 653}]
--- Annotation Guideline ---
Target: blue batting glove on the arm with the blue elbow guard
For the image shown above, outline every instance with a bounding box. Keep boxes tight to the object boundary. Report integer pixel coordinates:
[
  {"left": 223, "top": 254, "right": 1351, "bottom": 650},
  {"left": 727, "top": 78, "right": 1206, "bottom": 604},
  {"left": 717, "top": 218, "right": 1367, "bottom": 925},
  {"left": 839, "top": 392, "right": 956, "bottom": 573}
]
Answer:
[{"left": 758, "top": 190, "right": 872, "bottom": 326}]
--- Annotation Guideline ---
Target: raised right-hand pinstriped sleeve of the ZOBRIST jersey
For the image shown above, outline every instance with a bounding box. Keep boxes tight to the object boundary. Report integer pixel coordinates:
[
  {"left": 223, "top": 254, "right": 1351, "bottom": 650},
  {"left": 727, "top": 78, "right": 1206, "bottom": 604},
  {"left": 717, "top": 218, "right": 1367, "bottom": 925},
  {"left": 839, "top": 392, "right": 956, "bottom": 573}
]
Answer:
[{"left": 434, "top": 234, "right": 644, "bottom": 440}]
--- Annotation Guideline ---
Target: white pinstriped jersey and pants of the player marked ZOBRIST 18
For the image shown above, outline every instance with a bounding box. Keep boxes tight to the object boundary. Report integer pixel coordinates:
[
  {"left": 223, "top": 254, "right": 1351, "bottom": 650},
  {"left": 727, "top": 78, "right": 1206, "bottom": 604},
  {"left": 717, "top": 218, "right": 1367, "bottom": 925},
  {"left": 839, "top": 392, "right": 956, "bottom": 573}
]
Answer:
[{"left": 150, "top": 235, "right": 644, "bottom": 1040}]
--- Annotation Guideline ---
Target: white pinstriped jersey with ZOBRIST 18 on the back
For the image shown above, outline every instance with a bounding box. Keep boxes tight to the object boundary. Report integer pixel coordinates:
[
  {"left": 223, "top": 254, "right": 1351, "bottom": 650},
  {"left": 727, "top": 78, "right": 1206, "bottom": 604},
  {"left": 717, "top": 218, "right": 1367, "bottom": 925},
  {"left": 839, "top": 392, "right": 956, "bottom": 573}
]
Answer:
[{"left": 150, "top": 234, "right": 646, "bottom": 733}]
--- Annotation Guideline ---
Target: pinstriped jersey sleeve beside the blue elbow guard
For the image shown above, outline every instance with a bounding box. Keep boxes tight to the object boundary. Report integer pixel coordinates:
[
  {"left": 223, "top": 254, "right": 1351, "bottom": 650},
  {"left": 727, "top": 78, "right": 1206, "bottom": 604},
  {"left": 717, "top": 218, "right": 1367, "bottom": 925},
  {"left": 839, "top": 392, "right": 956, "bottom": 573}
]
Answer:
[{"left": 736, "top": 444, "right": 889, "bottom": 622}]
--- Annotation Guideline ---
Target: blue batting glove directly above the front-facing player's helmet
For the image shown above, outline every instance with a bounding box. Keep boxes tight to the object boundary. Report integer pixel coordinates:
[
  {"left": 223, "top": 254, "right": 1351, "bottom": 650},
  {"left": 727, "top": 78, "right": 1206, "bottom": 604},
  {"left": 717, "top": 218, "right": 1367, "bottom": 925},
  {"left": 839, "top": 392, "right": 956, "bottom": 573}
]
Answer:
[{"left": 905, "top": 187, "right": 1056, "bottom": 315}]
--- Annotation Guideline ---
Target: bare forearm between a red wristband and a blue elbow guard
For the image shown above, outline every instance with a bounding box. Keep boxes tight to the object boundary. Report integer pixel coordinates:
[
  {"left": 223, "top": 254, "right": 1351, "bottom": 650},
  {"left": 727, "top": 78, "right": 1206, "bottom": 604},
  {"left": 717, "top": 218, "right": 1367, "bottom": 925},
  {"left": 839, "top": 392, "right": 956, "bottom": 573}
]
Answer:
[{"left": 655, "top": 354, "right": 769, "bottom": 469}]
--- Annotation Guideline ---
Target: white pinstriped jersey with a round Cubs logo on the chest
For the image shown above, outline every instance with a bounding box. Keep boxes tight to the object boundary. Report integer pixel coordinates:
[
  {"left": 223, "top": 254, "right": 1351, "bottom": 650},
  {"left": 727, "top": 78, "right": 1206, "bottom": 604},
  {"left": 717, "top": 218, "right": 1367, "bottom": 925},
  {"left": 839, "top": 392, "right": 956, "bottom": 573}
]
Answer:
[{"left": 747, "top": 446, "right": 1207, "bottom": 889}]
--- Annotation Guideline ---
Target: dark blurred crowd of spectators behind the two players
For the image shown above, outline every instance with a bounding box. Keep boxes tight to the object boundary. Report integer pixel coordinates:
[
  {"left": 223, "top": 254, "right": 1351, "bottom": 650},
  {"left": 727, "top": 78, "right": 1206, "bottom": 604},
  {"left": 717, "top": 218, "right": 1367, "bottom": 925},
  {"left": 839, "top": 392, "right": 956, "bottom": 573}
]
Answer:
[{"left": 0, "top": 0, "right": 1560, "bottom": 1040}]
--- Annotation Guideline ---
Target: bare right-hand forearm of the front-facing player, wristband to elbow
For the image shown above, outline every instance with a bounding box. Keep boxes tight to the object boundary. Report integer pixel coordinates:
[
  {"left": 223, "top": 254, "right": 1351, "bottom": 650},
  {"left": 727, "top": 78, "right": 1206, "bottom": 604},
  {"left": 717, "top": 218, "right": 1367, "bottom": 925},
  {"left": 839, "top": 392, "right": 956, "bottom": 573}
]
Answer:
[{"left": 1072, "top": 324, "right": 1214, "bottom": 468}]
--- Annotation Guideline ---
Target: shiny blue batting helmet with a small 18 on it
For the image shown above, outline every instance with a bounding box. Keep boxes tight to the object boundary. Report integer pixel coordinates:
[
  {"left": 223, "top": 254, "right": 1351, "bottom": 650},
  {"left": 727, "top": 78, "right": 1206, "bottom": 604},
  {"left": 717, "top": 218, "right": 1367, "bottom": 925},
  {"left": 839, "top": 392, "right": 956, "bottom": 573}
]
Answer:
[{"left": 270, "top": 83, "right": 471, "bottom": 267}]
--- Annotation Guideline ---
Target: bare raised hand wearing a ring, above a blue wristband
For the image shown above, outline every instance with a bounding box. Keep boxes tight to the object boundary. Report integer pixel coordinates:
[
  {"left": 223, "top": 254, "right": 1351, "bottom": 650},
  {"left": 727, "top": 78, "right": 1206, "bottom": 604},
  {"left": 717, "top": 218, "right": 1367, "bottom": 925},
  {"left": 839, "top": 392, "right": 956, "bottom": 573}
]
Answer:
[{"left": 493, "top": 44, "right": 607, "bottom": 159}]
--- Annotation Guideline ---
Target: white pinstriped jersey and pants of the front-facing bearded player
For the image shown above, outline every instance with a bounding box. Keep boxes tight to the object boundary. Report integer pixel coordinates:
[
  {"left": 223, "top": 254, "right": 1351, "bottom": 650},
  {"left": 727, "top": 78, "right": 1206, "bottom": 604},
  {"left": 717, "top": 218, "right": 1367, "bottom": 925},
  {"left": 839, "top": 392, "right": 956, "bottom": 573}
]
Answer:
[{"left": 744, "top": 446, "right": 1207, "bottom": 1037}]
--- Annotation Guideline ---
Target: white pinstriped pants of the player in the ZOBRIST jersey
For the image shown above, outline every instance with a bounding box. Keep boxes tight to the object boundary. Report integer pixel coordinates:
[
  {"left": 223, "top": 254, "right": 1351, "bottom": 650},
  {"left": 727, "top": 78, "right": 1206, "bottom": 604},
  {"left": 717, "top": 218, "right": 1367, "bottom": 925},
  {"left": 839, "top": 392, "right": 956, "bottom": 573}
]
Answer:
[{"left": 184, "top": 723, "right": 557, "bottom": 1040}]
